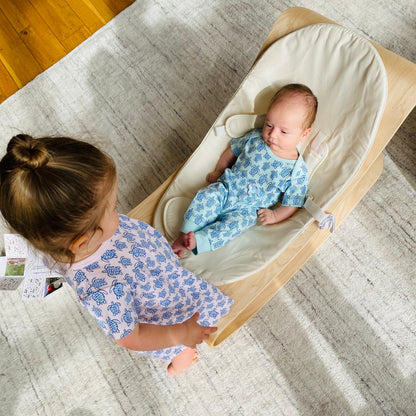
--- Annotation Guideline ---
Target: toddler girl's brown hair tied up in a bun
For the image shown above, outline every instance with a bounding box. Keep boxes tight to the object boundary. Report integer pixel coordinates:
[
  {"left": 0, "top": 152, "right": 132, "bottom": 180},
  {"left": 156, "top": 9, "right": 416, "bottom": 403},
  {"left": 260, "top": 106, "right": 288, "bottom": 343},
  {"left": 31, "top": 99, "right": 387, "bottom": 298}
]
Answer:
[{"left": 0, "top": 134, "right": 116, "bottom": 263}]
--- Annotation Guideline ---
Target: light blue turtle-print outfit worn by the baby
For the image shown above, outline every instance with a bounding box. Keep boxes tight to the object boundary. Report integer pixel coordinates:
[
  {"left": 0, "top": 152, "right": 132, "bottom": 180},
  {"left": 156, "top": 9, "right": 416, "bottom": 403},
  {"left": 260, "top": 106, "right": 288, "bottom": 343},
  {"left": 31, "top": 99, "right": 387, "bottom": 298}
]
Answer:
[{"left": 181, "top": 129, "right": 309, "bottom": 254}]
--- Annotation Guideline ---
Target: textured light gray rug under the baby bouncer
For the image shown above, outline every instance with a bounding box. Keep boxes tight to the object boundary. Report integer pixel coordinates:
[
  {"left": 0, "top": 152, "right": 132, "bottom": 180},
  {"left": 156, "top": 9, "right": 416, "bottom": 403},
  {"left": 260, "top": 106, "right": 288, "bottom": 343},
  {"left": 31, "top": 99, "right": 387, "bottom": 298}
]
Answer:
[{"left": 0, "top": 0, "right": 416, "bottom": 416}]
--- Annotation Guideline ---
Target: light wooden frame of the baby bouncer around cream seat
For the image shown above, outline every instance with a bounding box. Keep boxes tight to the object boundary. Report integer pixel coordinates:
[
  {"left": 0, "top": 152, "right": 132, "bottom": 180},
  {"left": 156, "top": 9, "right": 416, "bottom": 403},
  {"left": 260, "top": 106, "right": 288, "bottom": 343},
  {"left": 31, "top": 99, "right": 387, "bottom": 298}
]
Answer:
[{"left": 128, "top": 7, "right": 416, "bottom": 347}]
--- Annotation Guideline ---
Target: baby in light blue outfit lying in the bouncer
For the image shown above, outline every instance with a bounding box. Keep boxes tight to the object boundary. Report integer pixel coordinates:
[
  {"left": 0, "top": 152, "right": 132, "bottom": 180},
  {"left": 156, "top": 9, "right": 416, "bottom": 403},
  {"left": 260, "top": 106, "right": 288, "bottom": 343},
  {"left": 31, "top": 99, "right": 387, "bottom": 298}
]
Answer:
[{"left": 172, "top": 84, "right": 318, "bottom": 257}]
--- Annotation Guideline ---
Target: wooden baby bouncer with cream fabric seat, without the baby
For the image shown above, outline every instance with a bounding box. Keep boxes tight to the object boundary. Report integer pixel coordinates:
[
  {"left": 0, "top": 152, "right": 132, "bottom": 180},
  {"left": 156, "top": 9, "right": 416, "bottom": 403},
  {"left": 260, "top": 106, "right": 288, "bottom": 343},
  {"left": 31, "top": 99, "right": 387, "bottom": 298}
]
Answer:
[{"left": 129, "top": 8, "right": 416, "bottom": 346}]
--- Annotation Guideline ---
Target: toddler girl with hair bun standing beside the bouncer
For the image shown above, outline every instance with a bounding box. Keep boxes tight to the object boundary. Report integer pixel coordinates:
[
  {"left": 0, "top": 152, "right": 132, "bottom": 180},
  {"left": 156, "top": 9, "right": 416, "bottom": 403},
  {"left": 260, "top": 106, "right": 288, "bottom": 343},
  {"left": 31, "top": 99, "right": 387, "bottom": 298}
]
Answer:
[{"left": 0, "top": 134, "right": 232, "bottom": 375}]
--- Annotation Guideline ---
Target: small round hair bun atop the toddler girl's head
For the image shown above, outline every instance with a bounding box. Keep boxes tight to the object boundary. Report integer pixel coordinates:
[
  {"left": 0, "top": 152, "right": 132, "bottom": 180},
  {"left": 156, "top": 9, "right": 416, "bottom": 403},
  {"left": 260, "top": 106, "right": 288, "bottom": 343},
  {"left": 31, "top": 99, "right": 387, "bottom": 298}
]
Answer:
[{"left": 7, "top": 134, "right": 49, "bottom": 169}]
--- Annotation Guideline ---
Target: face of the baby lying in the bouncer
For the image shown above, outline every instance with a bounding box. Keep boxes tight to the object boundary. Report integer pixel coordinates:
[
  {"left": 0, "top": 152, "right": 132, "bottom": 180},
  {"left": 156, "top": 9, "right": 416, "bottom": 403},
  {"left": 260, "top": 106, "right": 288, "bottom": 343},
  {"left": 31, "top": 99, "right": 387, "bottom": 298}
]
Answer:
[{"left": 263, "top": 96, "right": 310, "bottom": 159}]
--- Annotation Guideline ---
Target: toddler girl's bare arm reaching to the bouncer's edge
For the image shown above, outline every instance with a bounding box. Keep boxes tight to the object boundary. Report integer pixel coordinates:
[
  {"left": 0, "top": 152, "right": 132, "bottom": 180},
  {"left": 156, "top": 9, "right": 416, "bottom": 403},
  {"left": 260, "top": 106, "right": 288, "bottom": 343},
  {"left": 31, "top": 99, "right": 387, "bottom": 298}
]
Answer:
[{"left": 115, "top": 312, "right": 217, "bottom": 351}]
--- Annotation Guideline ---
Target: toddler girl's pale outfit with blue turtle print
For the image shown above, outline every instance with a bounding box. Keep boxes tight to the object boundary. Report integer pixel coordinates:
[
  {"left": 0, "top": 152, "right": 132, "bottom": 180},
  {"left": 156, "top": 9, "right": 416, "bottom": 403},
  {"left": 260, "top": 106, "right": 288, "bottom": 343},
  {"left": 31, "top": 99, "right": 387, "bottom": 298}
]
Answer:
[{"left": 65, "top": 214, "right": 233, "bottom": 360}]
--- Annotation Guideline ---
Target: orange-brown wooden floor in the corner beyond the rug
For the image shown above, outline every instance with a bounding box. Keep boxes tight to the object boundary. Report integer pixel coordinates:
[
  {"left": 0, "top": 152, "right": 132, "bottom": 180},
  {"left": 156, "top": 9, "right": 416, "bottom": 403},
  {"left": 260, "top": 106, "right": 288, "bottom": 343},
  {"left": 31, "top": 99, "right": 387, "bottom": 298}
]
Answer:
[{"left": 0, "top": 0, "right": 134, "bottom": 103}]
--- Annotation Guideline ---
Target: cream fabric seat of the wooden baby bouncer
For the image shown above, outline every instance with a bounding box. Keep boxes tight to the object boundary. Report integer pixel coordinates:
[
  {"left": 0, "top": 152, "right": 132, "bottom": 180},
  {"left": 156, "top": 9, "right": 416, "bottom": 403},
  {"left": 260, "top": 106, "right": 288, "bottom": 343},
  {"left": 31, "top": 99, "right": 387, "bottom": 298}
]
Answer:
[{"left": 154, "top": 24, "right": 388, "bottom": 285}]
